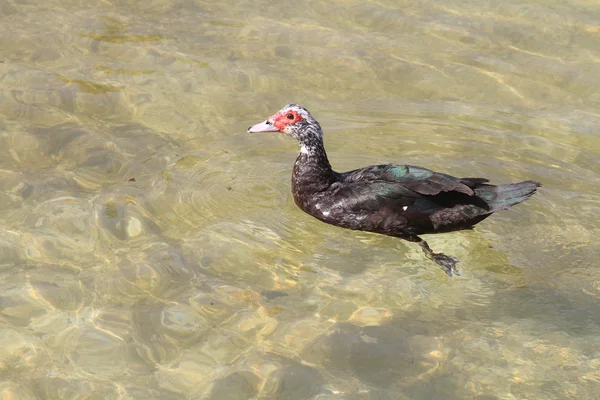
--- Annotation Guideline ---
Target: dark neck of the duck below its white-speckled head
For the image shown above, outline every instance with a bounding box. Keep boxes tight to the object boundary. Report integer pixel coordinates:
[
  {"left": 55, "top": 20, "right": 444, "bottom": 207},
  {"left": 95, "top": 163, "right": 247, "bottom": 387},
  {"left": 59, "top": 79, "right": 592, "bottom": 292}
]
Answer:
[{"left": 292, "top": 137, "right": 335, "bottom": 199}]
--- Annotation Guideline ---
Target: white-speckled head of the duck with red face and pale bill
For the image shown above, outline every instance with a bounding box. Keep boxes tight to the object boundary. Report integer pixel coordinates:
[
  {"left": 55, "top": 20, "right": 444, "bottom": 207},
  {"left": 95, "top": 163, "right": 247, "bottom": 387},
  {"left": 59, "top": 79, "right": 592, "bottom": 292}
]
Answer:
[{"left": 248, "top": 104, "right": 323, "bottom": 144}]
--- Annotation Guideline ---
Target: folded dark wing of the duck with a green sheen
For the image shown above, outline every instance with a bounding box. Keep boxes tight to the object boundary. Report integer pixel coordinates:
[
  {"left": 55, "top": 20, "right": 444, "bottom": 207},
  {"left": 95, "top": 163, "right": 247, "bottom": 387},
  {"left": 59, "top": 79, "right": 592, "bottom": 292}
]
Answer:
[{"left": 330, "top": 165, "right": 489, "bottom": 236}]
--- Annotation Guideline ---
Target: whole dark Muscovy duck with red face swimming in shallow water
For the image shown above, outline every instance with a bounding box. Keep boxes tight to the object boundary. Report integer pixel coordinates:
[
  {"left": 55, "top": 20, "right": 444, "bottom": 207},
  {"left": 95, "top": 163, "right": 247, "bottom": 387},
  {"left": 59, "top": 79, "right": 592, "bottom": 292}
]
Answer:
[{"left": 248, "top": 104, "right": 541, "bottom": 276}]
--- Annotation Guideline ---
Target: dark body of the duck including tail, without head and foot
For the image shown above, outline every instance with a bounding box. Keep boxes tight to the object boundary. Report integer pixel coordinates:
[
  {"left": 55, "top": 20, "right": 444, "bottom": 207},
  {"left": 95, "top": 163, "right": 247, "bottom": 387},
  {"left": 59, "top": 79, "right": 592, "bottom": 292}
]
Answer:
[{"left": 292, "top": 154, "right": 537, "bottom": 238}]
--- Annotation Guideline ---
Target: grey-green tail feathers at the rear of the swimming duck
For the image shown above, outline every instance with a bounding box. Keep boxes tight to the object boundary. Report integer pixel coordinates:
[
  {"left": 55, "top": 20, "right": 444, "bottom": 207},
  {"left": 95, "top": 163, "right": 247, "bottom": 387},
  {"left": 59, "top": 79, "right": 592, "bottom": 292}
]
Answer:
[{"left": 474, "top": 181, "right": 542, "bottom": 212}]
